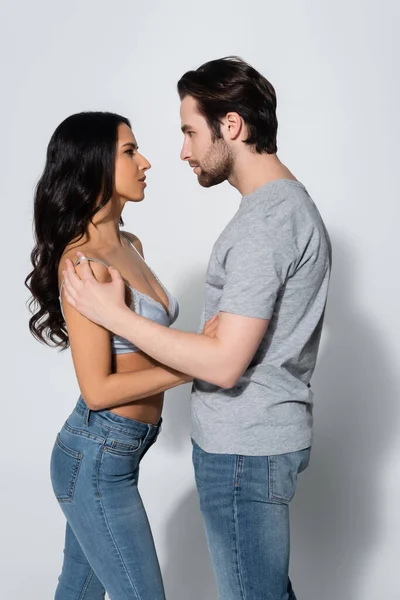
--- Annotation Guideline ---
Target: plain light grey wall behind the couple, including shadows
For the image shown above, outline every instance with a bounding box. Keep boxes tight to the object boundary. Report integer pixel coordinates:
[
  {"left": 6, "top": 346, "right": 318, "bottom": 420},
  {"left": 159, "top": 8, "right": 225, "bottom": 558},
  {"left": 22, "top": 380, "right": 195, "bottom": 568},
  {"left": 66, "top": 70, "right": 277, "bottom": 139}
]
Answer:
[{"left": 0, "top": 0, "right": 400, "bottom": 600}]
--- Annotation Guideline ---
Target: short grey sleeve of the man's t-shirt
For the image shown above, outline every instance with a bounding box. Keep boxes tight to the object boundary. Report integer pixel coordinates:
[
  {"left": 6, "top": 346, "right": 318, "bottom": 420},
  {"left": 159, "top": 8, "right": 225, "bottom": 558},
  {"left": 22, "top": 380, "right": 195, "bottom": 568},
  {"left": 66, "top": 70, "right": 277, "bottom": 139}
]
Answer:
[{"left": 219, "top": 218, "right": 293, "bottom": 319}]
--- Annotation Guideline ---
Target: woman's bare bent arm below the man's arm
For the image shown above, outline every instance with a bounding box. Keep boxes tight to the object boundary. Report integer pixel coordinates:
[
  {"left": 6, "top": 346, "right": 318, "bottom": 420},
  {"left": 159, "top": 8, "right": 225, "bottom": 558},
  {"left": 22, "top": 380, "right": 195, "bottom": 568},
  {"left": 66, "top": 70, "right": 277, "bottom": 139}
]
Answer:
[{"left": 62, "top": 263, "right": 192, "bottom": 410}]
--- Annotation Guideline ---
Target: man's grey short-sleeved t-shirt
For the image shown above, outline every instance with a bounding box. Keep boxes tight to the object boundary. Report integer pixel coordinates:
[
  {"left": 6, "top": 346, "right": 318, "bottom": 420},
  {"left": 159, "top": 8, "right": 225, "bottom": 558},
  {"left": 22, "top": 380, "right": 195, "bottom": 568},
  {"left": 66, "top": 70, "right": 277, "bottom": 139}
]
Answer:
[{"left": 192, "top": 179, "right": 331, "bottom": 456}]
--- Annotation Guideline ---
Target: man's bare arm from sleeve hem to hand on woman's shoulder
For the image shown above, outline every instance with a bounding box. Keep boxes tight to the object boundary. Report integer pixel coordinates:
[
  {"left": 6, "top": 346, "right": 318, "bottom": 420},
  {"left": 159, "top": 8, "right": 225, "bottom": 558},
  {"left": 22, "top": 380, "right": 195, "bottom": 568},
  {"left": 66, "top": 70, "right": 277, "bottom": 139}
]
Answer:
[{"left": 64, "top": 261, "right": 269, "bottom": 388}]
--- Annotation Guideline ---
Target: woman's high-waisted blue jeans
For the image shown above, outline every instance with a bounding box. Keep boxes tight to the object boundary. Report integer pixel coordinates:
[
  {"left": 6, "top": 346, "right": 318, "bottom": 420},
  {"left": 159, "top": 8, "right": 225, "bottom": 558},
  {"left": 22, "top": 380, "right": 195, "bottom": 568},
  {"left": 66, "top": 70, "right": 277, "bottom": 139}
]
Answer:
[{"left": 51, "top": 398, "right": 165, "bottom": 600}]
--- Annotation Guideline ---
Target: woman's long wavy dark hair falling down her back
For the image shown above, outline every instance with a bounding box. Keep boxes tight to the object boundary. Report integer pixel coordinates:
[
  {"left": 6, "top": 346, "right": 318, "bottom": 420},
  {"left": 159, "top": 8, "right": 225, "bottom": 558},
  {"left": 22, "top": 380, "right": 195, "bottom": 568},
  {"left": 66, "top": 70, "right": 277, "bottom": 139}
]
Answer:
[{"left": 25, "top": 112, "right": 131, "bottom": 349}]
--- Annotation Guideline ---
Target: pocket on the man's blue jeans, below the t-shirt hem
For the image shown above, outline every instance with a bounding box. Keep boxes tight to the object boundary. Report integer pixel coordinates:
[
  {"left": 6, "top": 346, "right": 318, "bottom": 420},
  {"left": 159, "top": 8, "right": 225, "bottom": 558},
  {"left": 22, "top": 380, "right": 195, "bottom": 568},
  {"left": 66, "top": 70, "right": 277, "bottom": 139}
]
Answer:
[{"left": 268, "top": 448, "right": 311, "bottom": 504}]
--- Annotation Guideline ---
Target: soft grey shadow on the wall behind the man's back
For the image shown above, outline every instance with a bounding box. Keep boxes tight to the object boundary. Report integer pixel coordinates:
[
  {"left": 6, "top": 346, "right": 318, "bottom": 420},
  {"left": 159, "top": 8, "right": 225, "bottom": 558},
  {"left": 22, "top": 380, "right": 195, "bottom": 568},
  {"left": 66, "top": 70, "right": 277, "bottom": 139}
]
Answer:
[{"left": 291, "top": 239, "right": 399, "bottom": 600}]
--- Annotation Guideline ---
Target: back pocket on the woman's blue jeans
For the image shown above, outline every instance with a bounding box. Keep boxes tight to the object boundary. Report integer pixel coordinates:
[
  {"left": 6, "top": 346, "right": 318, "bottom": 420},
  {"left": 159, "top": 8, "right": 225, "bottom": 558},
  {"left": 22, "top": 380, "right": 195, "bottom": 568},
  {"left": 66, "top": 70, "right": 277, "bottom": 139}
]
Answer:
[{"left": 50, "top": 434, "right": 83, "bottom": 502}]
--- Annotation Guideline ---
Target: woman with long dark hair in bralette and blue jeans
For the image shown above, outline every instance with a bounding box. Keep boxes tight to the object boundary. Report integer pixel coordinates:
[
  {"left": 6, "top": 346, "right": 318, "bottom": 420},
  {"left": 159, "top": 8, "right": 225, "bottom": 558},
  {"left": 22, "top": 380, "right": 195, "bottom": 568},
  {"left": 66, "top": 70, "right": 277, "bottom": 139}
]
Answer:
[{"left": 26, "top": 112, "right": 212, "bottom": 600}]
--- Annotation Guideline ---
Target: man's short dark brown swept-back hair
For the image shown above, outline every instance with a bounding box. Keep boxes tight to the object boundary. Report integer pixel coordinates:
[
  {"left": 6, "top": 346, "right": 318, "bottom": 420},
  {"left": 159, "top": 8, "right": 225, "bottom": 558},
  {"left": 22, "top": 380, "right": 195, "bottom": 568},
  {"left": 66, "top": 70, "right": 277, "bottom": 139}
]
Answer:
[{"left": 178, "top": 56, "right": 278, "bottom": 154}]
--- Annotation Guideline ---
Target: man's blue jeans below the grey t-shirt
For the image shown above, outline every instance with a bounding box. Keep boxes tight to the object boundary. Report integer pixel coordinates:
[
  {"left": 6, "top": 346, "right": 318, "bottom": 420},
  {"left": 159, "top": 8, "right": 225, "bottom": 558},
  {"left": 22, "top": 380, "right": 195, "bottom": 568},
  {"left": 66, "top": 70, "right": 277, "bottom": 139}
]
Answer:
[{"left": 193, "top": 443, "right": 310, "bottom": 600}]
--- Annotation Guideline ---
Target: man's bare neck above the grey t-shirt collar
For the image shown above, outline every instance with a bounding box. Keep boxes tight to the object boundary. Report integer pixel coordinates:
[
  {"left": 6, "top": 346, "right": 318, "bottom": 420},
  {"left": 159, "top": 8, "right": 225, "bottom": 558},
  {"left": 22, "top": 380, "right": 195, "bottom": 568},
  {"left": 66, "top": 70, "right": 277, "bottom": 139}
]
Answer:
[{"left": 228, "top": 151, "right": 296, "bottom": 196}]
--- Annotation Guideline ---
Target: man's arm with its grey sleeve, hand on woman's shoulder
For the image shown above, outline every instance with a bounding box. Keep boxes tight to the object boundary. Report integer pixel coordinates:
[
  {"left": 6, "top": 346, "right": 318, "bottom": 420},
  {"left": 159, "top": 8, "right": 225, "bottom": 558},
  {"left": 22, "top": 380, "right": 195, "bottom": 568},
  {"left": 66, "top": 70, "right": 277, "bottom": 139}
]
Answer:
[{"left": 66, "top": 208, "right": 290, "bottom": 388}]
